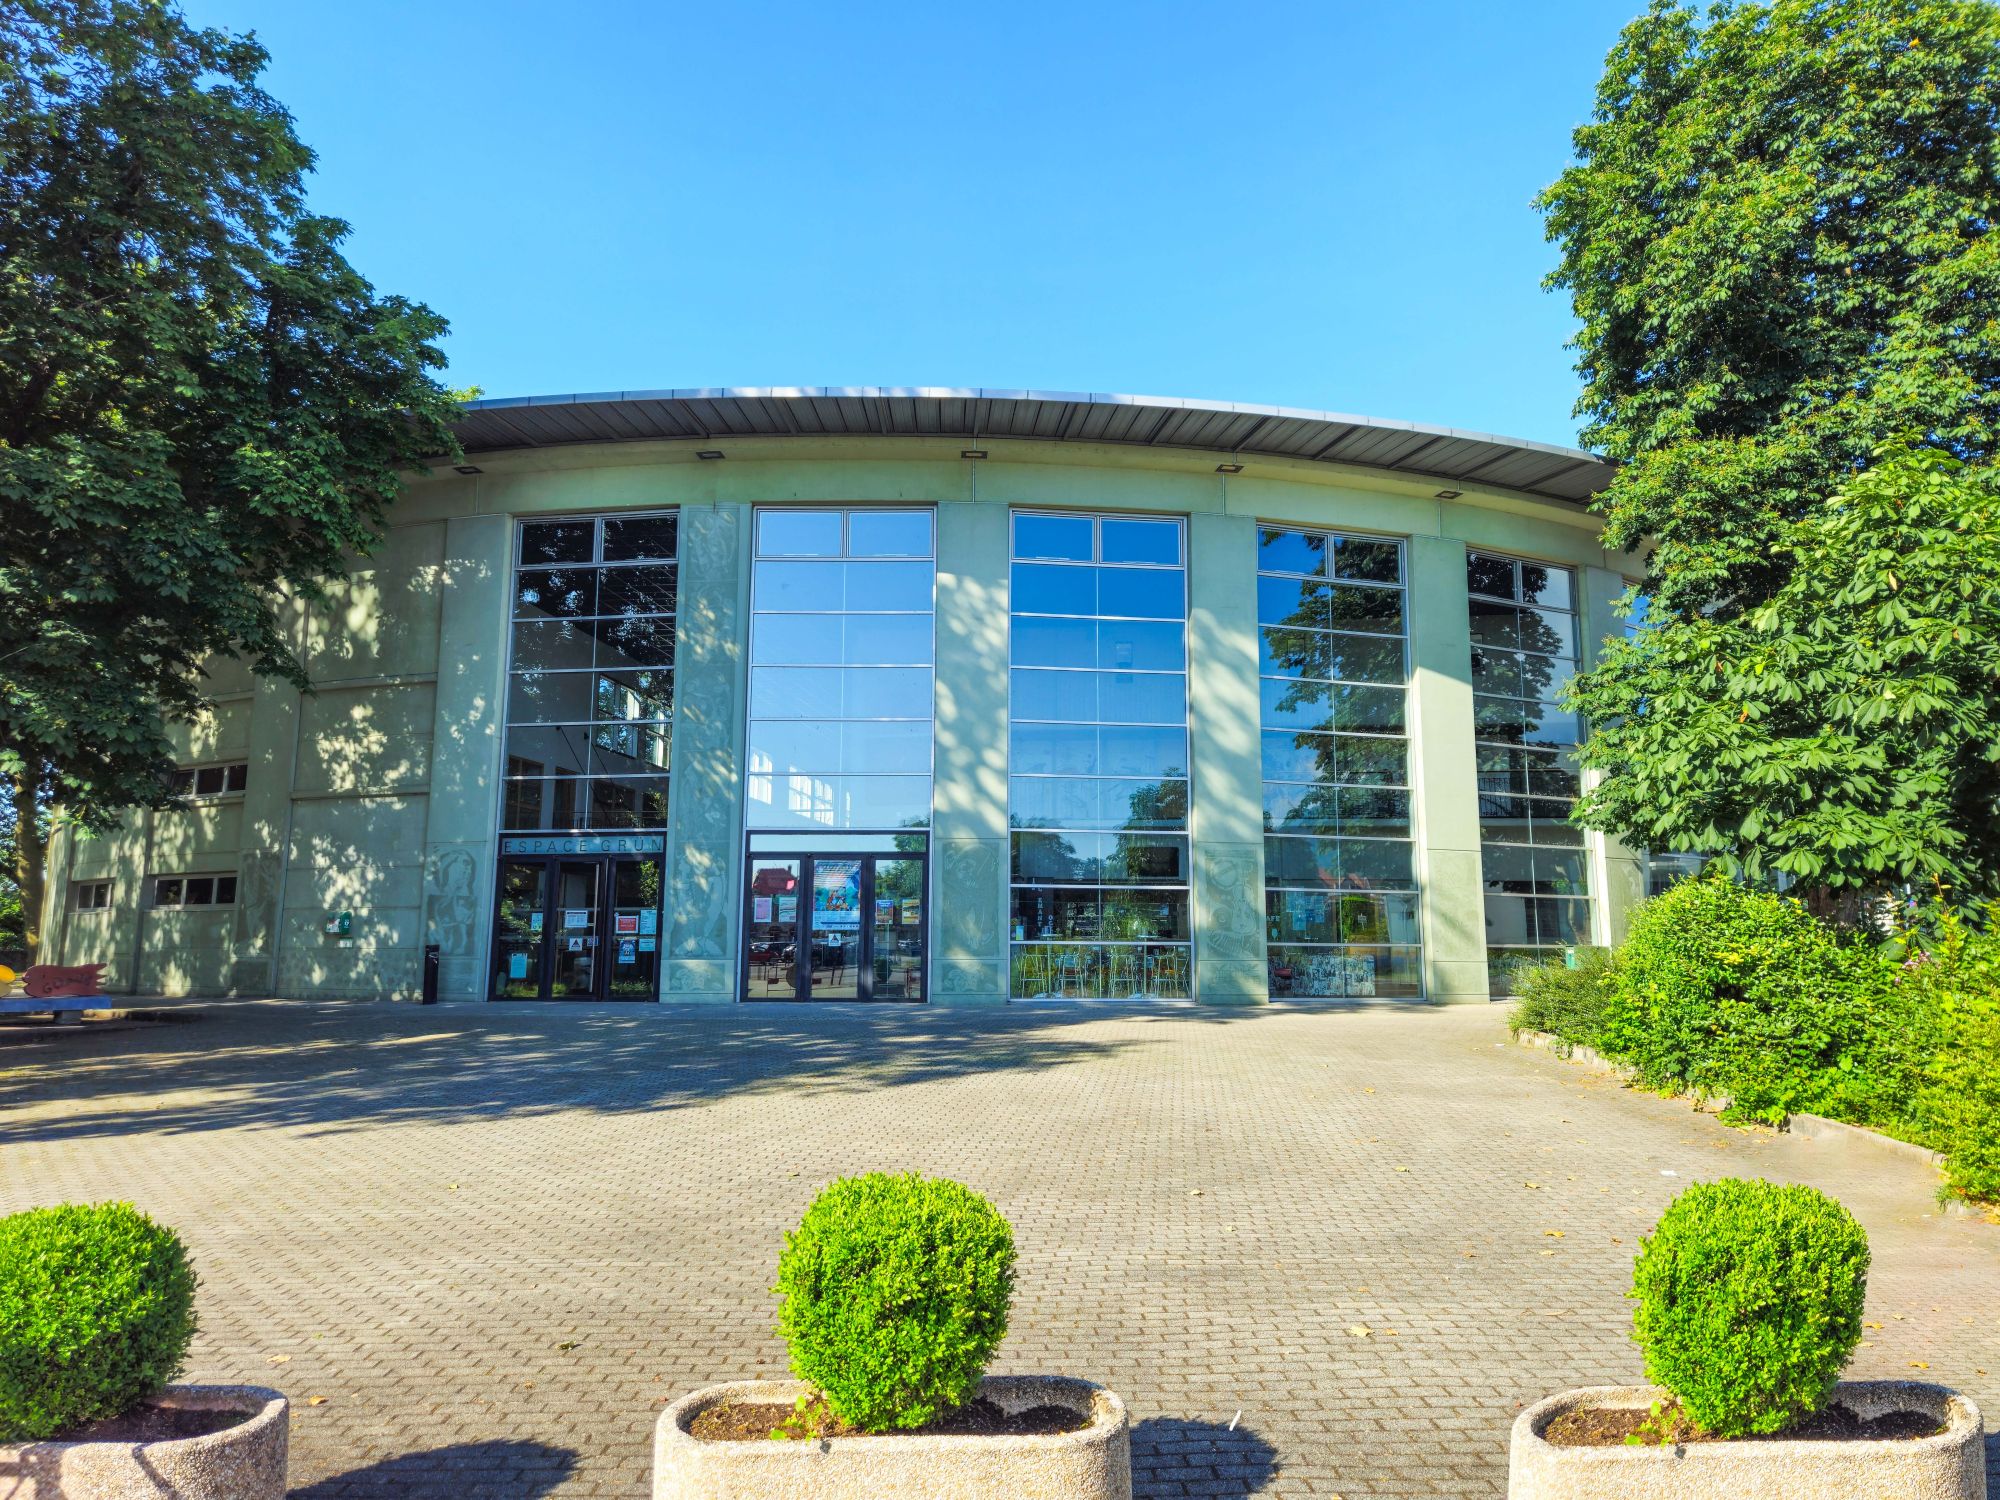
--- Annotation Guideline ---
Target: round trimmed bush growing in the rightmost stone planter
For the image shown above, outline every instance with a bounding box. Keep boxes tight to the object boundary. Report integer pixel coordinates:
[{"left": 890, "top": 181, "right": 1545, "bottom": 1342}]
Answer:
[{"left": 1632, "top": 1178, "right": 1868, "bottom": 1438}]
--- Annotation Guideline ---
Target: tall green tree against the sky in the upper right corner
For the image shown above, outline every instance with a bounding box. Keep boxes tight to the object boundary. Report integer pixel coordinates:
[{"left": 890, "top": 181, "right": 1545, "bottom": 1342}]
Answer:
[{"left": 1540, "top": 0, "right": 2000, "bottom": 620}]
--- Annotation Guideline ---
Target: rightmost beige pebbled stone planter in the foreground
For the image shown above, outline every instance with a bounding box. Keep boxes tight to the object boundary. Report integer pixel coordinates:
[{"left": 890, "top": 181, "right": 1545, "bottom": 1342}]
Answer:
[{"left": 1506, "top": 1380, "right": 1986, "bottom": 1500}]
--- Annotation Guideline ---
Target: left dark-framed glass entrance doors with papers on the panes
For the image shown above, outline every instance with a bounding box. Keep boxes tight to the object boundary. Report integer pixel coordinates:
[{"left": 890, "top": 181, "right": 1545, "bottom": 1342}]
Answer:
[{"left": 492, "top": 854, "right": 660, "bottom": 1000}]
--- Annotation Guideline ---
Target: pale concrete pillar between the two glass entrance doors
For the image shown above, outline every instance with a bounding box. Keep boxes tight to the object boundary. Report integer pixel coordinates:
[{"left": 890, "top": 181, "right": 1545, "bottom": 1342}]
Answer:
[{"left": 660, "top": 502, "right": 750, "bottom": 1004}]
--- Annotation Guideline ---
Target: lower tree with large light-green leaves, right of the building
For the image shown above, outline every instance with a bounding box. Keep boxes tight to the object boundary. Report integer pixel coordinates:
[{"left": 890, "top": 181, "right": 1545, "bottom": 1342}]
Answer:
[{"left": 1578, "top": 448, "right": 2000, "bottom": 904}]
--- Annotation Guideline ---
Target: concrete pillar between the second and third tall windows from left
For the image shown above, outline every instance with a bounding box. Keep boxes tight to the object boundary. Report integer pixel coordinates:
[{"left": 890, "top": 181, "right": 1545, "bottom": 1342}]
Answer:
[{"left": 930, "top": 502, "right": 1010, "bottom": 1004}]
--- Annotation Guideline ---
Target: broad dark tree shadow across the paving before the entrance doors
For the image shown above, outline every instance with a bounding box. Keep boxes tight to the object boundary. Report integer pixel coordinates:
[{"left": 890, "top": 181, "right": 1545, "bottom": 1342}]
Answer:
[{"left": 0, "top": 1000, "right": 1288, "bottom": 1146}]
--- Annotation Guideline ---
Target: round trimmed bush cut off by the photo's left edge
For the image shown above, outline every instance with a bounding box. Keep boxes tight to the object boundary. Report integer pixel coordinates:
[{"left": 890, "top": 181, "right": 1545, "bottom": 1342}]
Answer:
[{"left": 0, "top": 1204, "right": 194, "bottom": 1442}]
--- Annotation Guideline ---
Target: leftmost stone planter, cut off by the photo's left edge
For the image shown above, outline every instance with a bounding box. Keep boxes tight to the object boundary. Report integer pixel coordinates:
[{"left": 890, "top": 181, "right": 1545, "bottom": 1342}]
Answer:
[{"left": 0, "top": 1386, "right": 292, "bottom": 1500}]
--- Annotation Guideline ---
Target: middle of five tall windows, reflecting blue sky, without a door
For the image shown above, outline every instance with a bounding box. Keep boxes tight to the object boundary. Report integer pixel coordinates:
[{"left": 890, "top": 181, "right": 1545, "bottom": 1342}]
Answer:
[{"left": 1008, "top": 512, "right": 1192, "bottom": 1000}]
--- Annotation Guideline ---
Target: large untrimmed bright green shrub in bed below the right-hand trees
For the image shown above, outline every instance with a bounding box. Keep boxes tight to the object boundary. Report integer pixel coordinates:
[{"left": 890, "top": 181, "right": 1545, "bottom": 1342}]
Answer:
[{"left": 1602, "top": 876, "right": 1926, "bottom": 1122}]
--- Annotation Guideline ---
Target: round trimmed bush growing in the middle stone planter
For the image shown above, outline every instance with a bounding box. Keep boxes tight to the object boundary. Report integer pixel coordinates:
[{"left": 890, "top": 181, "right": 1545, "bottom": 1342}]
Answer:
[{"left": 776, "top": 1172, "right": 1014, "bottom": 1432}]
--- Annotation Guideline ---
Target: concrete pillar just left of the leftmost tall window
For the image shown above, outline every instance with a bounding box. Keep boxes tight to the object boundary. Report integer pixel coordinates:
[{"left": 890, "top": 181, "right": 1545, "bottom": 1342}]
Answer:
[{"left": 424, "top": 516, "right": 514, "bottom": 1000}]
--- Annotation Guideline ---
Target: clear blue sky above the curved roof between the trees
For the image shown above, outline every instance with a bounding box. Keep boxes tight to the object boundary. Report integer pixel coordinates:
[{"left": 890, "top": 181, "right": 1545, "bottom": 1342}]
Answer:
[{"left": 184, "top": 0, "right": 1638, "bottom": 442}]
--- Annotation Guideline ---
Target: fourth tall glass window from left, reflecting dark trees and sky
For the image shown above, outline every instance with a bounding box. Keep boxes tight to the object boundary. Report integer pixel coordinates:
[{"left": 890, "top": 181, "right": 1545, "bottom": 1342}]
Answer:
[{"left": 1256, "top": 526, "right": 1424, "bottom": 1000}]
